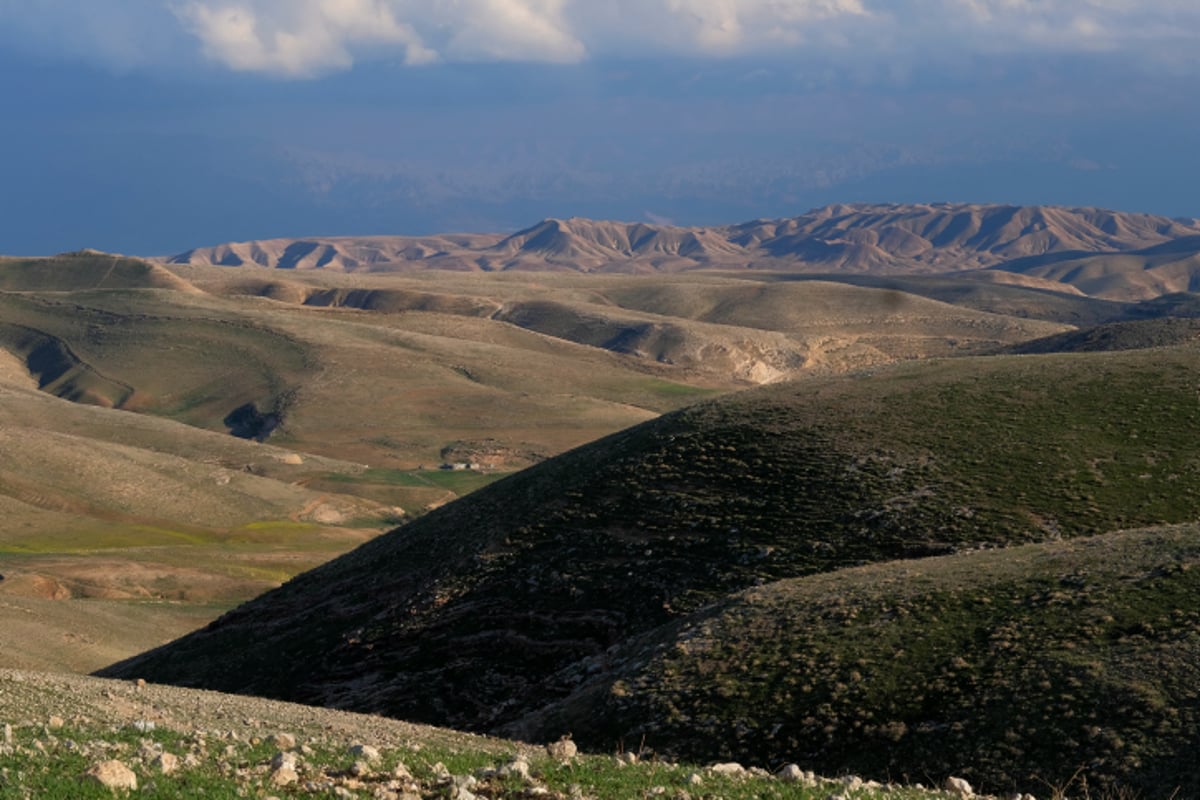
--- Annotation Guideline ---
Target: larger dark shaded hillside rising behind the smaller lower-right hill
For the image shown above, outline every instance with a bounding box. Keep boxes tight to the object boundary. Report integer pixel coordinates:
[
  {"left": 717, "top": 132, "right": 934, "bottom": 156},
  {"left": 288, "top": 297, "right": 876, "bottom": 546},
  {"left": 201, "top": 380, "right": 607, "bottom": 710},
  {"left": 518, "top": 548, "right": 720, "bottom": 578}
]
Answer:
[{"left": 106, "top": 348, "right": 1200, "bottom": 782}]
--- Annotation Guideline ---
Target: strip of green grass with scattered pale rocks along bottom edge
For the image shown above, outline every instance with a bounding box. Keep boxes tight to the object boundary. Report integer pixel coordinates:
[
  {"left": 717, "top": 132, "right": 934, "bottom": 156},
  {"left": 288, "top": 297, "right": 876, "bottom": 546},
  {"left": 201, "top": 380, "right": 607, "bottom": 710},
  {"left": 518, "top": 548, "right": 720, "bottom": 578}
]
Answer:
[{"left": 0, "top": 724, "right": 936, "bottom": 800}]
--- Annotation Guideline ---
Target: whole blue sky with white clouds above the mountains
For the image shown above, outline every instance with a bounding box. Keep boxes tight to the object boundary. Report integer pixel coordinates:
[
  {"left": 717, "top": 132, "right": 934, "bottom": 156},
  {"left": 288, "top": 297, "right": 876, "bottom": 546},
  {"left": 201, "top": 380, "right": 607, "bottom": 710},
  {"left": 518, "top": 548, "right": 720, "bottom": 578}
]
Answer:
[{"left": 0, "top": 0, "right": 1200, "bottom": 255}]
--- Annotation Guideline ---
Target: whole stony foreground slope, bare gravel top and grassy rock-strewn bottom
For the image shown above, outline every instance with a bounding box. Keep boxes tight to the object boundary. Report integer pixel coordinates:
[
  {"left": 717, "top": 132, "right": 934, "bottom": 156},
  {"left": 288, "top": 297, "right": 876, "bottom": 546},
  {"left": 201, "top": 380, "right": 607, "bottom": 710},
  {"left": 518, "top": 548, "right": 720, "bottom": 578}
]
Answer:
[{"left": 0, "top": 670, "right": 1012, "bottom": 800}]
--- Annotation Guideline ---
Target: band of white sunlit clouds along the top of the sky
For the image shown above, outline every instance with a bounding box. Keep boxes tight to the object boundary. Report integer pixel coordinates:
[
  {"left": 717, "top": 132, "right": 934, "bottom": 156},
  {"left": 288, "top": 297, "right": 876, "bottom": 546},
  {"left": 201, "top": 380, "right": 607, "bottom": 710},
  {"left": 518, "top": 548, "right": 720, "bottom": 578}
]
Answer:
[{"left": 0, "top": 0, "right": 1200, "bottom": 78}]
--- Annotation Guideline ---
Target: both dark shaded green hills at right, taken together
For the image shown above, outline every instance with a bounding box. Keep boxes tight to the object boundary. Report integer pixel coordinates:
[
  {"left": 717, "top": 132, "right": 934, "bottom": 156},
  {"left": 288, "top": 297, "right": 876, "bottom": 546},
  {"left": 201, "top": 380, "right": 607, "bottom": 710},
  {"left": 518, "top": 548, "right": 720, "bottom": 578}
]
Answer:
[{"left": 104, "top": 345, "right": 1200, "bottom": 796}]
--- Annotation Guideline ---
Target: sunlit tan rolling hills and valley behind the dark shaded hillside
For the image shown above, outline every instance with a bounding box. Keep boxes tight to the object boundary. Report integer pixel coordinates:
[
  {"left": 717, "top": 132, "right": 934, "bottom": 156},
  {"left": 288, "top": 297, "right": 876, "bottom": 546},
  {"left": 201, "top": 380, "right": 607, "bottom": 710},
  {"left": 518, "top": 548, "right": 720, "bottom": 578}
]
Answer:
[{"left": 0, "top": 252, "right": 1064, "bottom": 669}]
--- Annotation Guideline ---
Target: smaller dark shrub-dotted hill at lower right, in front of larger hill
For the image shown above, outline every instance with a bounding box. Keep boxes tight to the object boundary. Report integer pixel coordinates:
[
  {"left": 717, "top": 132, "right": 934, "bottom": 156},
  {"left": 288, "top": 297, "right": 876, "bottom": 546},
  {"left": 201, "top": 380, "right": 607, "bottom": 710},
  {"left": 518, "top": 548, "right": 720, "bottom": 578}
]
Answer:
[{"left": 530, "top": 525, "right": 1200, "bottom": 799}]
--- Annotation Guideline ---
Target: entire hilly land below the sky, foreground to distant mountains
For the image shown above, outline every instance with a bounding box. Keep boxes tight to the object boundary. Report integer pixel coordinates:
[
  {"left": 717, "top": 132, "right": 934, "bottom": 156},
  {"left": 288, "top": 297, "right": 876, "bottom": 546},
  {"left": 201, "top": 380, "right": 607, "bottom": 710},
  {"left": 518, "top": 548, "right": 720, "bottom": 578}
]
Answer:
[{"left": 0, "top": 204, "right": 1200, "bottom": 800}]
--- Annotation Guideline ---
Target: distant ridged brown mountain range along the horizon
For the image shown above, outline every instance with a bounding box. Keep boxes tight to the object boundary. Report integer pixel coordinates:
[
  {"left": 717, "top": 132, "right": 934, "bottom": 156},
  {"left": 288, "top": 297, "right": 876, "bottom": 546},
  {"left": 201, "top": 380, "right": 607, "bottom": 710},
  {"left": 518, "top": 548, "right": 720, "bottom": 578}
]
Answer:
[{"left": 164, "top": 204, "right": 1200, "bottom": 300}]
